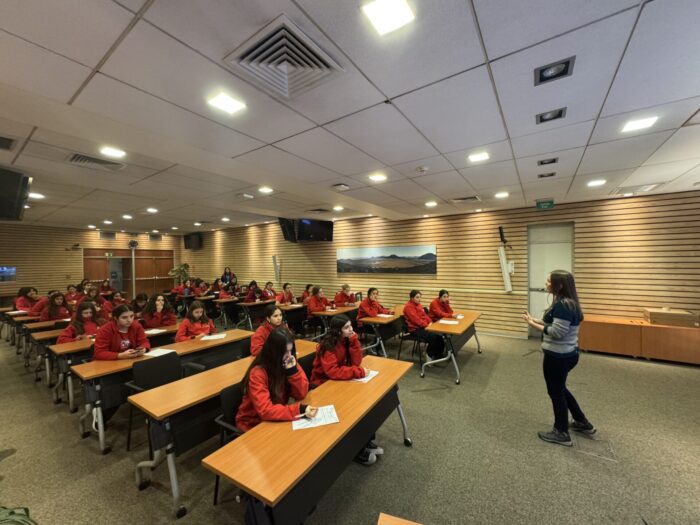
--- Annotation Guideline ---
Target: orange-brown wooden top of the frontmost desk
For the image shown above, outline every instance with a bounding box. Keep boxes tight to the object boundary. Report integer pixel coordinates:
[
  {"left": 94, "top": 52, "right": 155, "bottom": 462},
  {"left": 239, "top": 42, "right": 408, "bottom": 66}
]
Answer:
[{"left": 202, "top": 356, "right": 413, "bottom": 506}]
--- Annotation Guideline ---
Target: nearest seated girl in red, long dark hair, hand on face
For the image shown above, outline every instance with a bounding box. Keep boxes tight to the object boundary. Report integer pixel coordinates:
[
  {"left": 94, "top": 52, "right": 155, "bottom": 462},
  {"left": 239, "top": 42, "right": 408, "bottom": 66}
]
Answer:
[{"left": 236, "top": 329, "right": 318, "bottom": 432}]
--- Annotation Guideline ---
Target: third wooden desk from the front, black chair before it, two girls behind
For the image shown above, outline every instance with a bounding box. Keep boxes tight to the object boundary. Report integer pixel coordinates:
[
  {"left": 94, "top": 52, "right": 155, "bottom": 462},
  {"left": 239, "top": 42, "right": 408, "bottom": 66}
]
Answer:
[{"left": 71, "top": 330, "right": 253, "bottom": 454}]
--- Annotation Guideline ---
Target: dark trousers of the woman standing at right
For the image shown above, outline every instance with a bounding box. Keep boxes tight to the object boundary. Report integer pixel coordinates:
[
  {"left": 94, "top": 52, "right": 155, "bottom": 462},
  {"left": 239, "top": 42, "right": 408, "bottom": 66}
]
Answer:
[{"left": 542, "top": 352, "right": 588, "bottom": 432}]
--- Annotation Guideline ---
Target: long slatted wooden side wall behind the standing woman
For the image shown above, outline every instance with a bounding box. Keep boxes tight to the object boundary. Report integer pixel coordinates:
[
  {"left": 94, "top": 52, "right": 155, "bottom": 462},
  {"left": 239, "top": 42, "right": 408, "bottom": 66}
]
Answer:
[{"left": 181, "top": 192, "right": 700, "bottom": 337}]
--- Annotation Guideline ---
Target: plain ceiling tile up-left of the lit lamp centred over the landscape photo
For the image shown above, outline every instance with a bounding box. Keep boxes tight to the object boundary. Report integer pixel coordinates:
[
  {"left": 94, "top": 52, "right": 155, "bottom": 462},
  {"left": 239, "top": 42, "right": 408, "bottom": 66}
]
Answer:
[{"left": 275, "top": 128, "right": 382, "bottom": 175}]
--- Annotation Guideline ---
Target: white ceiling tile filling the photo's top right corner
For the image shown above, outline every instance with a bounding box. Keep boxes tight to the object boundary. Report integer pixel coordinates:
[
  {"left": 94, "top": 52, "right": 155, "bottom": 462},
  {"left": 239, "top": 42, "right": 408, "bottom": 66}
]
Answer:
[{"left": 603, "top": 0, "right": 700, "bottom": 115}]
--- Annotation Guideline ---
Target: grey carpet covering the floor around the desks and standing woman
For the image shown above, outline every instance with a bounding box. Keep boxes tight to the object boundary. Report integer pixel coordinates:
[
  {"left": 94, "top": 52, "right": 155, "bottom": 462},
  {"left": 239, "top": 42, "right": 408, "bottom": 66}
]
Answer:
[{"left": 0, "top": 336, "right": 700, "bottom": 525}]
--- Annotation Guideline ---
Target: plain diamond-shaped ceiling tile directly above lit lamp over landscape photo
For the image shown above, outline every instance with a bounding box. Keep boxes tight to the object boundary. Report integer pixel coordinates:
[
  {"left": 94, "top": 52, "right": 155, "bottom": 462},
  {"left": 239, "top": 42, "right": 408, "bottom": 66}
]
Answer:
[{"left": 325, "top": 104, "right": 437, "bottom": 164}]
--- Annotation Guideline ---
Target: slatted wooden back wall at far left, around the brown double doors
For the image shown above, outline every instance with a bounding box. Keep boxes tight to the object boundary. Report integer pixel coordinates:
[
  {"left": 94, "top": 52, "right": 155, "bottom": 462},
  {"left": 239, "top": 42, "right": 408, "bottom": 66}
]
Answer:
[{"left": 0, "top": 223, "right": 182, "bottom": 296}]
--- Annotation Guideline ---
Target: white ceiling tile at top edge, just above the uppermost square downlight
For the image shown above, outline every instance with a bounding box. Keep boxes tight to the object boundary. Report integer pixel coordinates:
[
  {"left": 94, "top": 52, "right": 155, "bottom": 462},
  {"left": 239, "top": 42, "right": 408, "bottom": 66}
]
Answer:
[{"left": 474, "top": 0, "right": 639, "bottom": 58}]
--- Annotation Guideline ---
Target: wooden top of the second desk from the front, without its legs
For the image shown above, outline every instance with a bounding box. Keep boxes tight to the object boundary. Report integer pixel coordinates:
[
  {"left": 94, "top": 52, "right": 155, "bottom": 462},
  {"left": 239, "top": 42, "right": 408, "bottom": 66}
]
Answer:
[{"left": 129, "top": 340, "right": 316, "bottom": 421}]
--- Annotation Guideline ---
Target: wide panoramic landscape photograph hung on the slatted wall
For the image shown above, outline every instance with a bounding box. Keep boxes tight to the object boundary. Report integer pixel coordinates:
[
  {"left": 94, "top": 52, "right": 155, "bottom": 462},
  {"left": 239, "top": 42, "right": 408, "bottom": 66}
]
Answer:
[{"left": 336, "top": 245, "right": 437, "bottom": 274}]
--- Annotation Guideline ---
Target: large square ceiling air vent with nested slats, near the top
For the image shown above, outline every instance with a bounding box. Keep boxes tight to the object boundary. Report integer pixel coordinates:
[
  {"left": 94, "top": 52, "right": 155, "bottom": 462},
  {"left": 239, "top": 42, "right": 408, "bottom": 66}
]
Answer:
[{"left": 224, "top": 15, "right": 343, "bottom": 99}]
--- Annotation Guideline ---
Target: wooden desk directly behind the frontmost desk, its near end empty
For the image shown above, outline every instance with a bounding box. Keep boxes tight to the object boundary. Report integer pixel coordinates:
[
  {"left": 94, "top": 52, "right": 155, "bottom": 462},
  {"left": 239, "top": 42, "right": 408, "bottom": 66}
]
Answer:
[{"left": 129, "top": 340, "right": 316, "bottom": 518}]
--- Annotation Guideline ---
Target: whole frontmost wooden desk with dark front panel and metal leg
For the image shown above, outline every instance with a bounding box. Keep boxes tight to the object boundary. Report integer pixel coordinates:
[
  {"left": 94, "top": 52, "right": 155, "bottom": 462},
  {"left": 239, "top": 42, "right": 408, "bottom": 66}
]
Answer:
[{"left": 202, "top": 356, "right": 412, "bottom": 524}]
